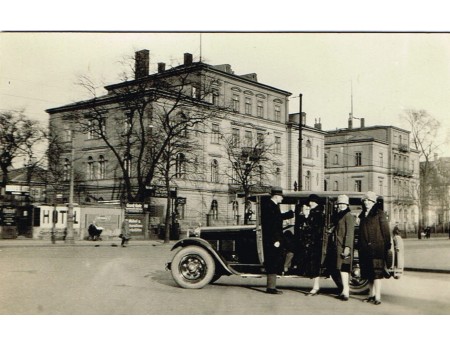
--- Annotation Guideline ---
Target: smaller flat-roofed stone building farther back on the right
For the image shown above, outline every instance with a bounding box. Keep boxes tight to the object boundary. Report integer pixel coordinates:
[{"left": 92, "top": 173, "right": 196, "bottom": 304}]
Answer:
[{"left": 324, "top": 116, "right": 420, "bottom": 232}]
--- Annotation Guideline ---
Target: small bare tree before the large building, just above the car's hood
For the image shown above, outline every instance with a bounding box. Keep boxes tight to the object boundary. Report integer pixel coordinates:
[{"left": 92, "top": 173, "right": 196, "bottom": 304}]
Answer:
[{"left": 224, "top": 129, "right": 277, "bottom": 224}]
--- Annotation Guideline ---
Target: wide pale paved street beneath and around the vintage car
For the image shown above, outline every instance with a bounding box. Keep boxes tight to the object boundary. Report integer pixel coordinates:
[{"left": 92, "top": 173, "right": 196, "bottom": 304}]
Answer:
[{"left": 0, "top": 240, "right": 450, "bottom": 315}]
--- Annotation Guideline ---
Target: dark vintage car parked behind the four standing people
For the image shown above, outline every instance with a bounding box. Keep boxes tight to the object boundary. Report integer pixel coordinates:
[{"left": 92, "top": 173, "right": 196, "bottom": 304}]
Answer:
[{"left": 166, "top": 192, "right": 403, "bottom": 293}]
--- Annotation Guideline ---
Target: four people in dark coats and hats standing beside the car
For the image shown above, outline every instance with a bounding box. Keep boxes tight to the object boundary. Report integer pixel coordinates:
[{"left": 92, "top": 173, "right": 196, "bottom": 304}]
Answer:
[{"left": 261, "top": 187, "right": 391, "bottom": 305}]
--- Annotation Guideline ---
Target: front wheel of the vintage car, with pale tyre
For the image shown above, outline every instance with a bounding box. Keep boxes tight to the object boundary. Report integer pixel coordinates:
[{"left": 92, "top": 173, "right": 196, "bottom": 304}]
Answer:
[{"left": 171, "top": 246, "right": 216, "bottom": 289}]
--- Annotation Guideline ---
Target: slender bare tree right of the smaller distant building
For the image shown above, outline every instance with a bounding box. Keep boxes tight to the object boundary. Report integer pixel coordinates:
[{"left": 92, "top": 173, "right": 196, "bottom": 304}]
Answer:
[{"left": 402, "top": 109, "right": 440, "bottom": 236}]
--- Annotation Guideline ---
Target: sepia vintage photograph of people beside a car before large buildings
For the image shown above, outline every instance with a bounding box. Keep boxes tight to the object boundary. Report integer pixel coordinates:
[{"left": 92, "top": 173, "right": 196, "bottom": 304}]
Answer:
[{"left": 0, "top": 31, "right": 450, "bottom": 315}]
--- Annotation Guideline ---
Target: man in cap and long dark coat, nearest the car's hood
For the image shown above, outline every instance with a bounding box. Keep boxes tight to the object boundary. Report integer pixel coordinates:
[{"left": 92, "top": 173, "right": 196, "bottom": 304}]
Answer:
[{"left": 261, "top": 187, "right": 294, "bottom": 294}]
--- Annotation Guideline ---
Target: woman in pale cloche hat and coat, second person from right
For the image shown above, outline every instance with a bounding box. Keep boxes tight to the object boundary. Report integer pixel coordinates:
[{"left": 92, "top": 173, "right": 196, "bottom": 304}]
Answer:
[{"left": 327, "top": 195, "right": 355, "bottom": 301}]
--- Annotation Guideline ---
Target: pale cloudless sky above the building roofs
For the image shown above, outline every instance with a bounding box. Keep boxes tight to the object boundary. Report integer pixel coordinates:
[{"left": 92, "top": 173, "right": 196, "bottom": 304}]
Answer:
[{"left": 0, "top": 32, "right": 450, "bottom": 155}]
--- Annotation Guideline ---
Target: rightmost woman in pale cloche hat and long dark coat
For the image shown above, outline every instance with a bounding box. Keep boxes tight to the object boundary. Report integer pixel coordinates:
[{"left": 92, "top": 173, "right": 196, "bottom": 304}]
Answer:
[{"left": 359, "top": 192, "right": 391, "bottom": 305}]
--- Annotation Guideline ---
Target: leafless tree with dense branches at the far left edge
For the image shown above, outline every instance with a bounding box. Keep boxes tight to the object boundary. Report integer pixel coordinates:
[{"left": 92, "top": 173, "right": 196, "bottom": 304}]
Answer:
[{"left": 0, "top": 111, "right": 43, "bottom": 186}]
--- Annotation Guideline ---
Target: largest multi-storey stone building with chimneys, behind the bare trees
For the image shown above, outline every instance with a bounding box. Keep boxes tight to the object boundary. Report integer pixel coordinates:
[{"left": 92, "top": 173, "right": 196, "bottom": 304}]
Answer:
[{"left": 47, "top": 50, "right": 325, "bottom": 231}]
